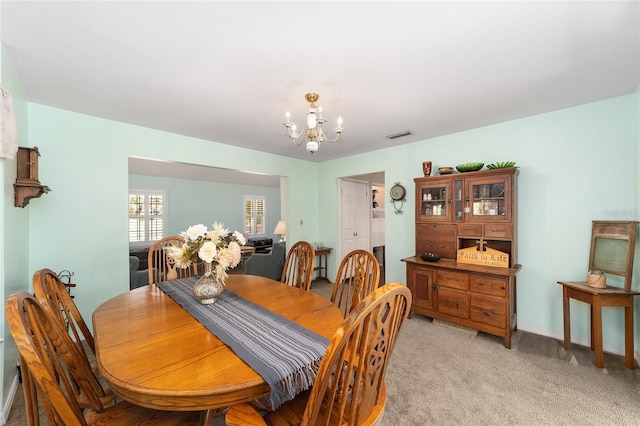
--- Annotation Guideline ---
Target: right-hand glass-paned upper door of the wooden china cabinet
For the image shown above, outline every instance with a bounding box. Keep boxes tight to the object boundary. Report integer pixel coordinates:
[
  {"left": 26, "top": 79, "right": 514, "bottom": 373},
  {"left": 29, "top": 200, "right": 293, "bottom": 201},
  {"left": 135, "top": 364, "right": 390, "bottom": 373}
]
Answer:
[{"left": 463, "top": 177, "right": 511, "bottom": 222}]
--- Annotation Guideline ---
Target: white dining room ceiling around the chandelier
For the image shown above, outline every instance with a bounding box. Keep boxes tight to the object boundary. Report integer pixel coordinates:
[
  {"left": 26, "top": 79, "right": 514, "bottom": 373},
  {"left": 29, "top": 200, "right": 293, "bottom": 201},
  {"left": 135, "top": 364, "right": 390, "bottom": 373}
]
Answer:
[{"left": 0, "top": 0, "right": 640, "bottom": 171}]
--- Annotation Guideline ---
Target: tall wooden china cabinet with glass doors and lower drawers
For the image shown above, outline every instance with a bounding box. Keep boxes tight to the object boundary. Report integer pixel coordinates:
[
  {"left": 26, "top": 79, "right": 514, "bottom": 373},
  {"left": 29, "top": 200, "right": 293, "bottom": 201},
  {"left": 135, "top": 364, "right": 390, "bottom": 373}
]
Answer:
[{"left": 402, "top": 167, "right": 521, "bottom": 348}]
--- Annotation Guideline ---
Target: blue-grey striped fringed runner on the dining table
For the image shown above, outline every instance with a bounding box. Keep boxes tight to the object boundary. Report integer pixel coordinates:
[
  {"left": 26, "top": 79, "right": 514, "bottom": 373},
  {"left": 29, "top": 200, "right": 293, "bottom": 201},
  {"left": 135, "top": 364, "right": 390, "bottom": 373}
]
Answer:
[{"left": 157, "top": 277, "right": 329, "bottom": 410}]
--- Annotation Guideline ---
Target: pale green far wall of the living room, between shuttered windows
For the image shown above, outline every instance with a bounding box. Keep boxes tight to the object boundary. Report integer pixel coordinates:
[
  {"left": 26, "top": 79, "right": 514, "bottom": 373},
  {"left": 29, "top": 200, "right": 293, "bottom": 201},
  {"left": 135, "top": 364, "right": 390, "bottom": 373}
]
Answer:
[{"left": 129, "top": 174, "right": 280, "bottom": 239}]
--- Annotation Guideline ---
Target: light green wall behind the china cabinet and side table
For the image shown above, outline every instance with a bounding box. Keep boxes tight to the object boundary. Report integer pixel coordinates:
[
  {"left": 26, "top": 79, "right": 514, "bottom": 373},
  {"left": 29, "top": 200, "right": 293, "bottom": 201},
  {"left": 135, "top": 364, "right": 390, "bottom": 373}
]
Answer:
[{"left": 319, "top": 95, "right": 640, "bottom": 353}]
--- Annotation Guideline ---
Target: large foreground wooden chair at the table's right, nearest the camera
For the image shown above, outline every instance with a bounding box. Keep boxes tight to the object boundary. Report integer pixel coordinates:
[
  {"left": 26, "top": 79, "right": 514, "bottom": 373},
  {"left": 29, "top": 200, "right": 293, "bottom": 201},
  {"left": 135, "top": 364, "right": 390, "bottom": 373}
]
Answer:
[{"left": 225, "top": 283, "right": 411, "bottom": 426}]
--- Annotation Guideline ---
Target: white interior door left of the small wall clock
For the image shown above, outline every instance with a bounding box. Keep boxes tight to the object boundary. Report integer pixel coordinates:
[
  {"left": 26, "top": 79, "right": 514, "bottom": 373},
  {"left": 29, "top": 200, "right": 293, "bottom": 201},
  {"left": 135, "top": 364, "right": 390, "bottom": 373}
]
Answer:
[{"left": 340, "top": 180, "right": 371, "bottom": 258}]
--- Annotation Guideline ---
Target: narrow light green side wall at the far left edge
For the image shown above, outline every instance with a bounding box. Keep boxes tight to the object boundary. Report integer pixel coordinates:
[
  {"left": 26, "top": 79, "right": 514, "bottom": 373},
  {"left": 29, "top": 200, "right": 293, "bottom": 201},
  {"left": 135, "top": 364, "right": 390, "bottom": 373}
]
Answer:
[{"left": 0, "top": 49, "right": 31, "bottom": 420}]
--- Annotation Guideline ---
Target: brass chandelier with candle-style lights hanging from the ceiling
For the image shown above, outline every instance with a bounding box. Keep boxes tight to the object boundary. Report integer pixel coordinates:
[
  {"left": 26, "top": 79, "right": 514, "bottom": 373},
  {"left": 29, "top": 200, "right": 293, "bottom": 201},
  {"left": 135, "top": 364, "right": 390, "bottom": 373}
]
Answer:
[{"left": 282, "top": 93, "right": 342, "bottom": 154}]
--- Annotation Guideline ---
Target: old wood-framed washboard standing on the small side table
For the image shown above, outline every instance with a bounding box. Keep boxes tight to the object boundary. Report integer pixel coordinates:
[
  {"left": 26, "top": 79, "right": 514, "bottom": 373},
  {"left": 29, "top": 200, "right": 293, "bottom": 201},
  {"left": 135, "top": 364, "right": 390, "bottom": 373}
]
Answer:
[{"left": 589, "top": 220, "right": 638, "bottom": 291}]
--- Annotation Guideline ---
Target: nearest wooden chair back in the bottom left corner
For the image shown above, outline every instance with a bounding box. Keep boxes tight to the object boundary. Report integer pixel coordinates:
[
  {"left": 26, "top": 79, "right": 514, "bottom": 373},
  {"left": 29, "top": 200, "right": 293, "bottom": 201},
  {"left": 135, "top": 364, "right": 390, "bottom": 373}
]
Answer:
[{"left": 5, "top": 292, "right": 109, "bottom": 425}]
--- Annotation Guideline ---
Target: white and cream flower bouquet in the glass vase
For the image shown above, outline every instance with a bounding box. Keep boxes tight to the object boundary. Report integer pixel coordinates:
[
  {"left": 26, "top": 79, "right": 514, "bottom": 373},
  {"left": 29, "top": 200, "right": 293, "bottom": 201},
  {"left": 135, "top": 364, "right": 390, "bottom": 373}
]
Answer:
[{"left": 166, "top": 222, "right": 247, "bottom": 282}]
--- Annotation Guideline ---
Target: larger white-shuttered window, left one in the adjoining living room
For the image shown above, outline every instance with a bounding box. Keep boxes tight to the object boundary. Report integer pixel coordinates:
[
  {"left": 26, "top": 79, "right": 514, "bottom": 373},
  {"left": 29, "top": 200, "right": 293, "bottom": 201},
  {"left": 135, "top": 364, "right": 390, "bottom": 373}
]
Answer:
[{"left": 129, "top": 189, "right": 167, "bottom": 245}]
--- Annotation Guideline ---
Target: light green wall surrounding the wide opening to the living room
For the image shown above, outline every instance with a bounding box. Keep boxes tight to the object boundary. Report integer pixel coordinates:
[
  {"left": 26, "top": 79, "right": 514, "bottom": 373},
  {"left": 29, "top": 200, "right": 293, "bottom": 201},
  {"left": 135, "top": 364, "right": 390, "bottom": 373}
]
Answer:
[{"left": 29, "top": 104, "right": 318, "bottom": 330}]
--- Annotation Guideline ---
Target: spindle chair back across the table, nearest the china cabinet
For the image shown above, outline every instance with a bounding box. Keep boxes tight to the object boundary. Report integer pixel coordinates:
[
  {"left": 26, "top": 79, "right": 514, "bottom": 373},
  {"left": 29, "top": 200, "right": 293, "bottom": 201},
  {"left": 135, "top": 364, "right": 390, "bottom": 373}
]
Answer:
[{"left": 331, "top": 250, "right": 380, "bottom": 317}]
